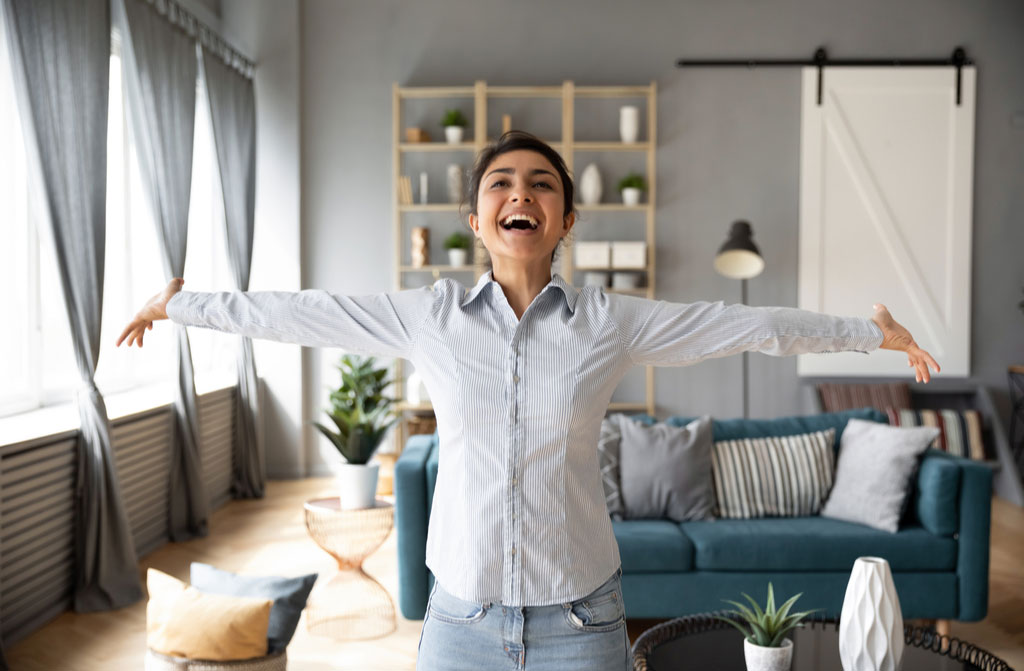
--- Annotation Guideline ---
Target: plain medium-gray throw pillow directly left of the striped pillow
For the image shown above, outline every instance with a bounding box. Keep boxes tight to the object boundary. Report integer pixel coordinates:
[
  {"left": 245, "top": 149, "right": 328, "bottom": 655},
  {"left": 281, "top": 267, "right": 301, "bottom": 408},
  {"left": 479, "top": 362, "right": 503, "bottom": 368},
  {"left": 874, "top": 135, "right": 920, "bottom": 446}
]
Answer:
[{"left": 609, "top": 416, "right": 715, "bottom": 521}]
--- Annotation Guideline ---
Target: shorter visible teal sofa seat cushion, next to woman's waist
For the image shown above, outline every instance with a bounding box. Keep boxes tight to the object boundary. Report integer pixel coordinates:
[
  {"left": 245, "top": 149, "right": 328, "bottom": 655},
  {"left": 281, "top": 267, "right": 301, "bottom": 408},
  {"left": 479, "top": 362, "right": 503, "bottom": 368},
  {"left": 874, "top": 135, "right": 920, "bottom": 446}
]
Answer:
[{"left": 611, "top": 519, "right": 693, "bottom": 574}]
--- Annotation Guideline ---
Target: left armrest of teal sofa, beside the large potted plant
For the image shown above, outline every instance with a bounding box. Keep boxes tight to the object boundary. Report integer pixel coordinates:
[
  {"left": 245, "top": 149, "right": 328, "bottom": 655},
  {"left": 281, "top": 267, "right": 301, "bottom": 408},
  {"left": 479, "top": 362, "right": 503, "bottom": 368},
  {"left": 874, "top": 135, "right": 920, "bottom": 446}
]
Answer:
[{"left": 394, "top": 433, "right": 436, "bottom": 620}]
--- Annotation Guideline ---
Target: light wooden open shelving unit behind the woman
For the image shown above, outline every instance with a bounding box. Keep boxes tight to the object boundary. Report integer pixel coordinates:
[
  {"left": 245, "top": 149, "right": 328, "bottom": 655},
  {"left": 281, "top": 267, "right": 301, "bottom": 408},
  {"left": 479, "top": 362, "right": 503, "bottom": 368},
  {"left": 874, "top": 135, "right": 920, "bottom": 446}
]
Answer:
[{"left": 391, "top": 81, "right": 657, "bottom": 453}]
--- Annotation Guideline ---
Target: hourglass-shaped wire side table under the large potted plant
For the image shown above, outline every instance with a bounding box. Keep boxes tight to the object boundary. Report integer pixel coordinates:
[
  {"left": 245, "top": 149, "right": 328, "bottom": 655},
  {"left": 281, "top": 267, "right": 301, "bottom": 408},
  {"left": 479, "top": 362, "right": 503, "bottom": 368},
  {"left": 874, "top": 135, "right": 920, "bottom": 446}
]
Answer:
[{"left": 304, "top": 497, "right": 396, "bottom": 640}]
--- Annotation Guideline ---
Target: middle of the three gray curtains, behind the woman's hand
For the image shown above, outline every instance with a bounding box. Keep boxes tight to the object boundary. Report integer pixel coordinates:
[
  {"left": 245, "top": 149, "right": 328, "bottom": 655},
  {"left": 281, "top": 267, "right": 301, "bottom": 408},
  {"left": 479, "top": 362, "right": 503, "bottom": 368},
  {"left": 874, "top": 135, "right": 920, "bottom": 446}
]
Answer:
[{"left": 113, "top": 0, "right": 208, "bottom": 541}]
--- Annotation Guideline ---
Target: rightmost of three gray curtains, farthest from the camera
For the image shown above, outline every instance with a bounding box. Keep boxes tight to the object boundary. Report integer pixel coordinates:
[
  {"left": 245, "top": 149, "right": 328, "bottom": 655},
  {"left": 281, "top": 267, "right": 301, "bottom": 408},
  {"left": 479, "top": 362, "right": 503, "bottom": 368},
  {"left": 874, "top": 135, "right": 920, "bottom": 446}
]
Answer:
[{"left": 203, "top": 48, "right": 266, "bottom": 498}]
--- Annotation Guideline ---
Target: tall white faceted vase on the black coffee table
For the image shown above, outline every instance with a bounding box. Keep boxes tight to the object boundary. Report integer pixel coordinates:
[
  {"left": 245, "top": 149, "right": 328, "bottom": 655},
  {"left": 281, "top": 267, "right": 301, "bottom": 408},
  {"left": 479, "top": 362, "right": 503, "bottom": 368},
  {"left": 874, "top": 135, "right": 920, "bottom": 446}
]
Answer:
[{"left": 839, "top": 557, "right": 903, "bottom": 671}]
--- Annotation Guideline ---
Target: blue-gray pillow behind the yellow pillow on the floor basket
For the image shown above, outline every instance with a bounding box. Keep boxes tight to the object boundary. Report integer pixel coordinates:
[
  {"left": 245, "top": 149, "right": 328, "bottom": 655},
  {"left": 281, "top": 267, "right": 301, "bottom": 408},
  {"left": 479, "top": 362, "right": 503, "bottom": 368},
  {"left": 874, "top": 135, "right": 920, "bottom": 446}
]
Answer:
[{"left": 190, "top": 561, "right": 316, "bottom": 654}]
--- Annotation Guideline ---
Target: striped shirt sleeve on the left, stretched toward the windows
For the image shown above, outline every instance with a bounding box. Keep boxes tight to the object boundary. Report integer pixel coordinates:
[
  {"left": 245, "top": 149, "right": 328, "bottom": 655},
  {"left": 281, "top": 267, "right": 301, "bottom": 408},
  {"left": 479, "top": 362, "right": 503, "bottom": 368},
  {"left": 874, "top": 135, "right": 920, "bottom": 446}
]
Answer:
[{"left": 167, "top": 284, "right": 443, "bottom": 359}]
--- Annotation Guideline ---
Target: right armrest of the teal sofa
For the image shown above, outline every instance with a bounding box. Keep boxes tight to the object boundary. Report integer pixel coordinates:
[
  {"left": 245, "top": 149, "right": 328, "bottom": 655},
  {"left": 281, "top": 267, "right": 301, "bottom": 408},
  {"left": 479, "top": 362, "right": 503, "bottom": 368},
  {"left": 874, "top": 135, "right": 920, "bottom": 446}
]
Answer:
[{"left": 919, "top": 449, "right": 992, "bottom": 622}]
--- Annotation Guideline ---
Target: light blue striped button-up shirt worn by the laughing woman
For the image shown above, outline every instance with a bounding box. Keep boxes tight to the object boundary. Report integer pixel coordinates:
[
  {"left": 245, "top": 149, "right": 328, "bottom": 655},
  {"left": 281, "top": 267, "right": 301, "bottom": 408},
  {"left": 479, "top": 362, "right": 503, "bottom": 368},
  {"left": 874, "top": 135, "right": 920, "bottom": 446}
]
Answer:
[{"left": 167, "top": 271, "right": 882, "bottom": 606}]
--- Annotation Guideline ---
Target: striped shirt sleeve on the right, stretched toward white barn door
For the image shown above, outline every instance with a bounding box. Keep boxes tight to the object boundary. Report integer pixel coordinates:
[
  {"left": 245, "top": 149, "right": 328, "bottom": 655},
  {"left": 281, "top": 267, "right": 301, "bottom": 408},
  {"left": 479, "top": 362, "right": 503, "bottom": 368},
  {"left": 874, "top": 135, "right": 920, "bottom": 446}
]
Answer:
[{"left": 602, "top": 292, "right": 883, "bottom": 366}]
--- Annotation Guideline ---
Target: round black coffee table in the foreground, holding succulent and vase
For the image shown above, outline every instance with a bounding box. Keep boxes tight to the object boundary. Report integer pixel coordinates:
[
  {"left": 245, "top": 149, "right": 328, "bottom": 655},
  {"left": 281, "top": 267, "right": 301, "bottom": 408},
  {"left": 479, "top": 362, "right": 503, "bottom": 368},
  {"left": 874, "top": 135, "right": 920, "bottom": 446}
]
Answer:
[{"left": 633, "top": 614, "right": 1013, "bottom": 671}]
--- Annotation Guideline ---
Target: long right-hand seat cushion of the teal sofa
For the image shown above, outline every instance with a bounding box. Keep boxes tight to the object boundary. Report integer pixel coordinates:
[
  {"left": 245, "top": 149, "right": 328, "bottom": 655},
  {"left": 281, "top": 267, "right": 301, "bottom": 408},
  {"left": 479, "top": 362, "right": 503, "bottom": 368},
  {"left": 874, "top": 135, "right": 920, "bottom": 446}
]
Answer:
[{"left": 680, "top": 516, "right": 956, "bottom": 572}]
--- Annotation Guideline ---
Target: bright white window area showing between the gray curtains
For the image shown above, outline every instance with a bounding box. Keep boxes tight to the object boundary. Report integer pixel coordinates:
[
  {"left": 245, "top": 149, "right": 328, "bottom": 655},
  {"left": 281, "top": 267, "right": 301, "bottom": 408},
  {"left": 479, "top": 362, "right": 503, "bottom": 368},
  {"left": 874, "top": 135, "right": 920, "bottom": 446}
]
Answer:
[{"left": 0, "top": 21, "right": 238, "bottom": 417}]
